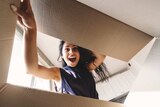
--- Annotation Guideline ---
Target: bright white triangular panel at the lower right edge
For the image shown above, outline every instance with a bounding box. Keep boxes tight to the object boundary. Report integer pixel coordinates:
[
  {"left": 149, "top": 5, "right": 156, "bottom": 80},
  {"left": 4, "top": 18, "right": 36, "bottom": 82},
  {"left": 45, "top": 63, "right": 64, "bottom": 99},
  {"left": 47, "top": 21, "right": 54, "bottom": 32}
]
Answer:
[{"left": 125, "top": 39, "right": 160, "bottom": 107}]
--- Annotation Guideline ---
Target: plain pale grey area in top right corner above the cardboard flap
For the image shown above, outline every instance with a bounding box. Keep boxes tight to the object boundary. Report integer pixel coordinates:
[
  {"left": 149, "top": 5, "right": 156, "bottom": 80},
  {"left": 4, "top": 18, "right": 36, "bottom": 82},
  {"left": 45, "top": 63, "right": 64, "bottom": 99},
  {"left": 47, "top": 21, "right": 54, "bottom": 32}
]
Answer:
[{"left": 77, "top": 0, "right": 160, "bottom": 37}]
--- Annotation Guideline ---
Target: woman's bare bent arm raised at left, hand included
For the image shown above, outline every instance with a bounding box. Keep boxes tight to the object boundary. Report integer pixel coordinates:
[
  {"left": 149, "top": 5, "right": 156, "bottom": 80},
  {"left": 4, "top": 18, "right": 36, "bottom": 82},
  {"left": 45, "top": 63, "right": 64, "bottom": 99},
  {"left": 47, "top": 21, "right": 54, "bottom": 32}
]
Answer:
[{"left": 10, "top": 0, "right": 60, "bottom": 80}]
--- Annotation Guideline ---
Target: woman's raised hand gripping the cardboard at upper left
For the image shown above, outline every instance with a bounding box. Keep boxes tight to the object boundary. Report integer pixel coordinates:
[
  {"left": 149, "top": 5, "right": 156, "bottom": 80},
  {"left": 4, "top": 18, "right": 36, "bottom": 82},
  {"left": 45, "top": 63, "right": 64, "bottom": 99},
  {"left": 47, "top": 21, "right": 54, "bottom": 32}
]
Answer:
[{"left": 10, "top": 0, "right": 36, "bottom": 30}]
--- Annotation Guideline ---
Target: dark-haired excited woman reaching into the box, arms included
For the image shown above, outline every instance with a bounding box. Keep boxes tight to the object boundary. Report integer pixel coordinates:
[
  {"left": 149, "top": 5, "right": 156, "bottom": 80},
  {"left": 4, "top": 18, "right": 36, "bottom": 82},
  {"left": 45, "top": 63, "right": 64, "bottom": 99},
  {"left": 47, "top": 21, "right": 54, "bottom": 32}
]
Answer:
[{"left": 10, "top": 0, "right": 105, "bottom": 98}]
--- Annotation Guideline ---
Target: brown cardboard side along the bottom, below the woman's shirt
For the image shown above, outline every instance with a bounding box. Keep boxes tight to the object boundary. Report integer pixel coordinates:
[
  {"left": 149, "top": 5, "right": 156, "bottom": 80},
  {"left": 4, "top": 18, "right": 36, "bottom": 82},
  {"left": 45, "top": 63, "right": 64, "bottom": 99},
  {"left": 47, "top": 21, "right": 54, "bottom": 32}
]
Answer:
[{"left": 0, "top": 84, "right": 124, "bottom": 107}]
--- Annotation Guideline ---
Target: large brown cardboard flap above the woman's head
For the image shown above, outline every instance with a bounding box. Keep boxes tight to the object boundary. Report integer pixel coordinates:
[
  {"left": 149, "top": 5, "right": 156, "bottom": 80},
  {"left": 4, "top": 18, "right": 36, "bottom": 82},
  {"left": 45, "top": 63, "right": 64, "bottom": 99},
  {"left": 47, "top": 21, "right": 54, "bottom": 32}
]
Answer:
[{"left": 32, "top": 0, "right": 152, "bottom": 61}]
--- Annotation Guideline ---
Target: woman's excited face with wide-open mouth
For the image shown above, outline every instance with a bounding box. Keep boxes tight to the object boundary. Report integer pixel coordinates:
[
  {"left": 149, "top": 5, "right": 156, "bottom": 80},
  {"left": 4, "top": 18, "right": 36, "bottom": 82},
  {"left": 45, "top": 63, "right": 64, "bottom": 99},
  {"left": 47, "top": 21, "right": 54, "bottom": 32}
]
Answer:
[{"left": 62, "top": 42, "right": 80, "bottom": 67}]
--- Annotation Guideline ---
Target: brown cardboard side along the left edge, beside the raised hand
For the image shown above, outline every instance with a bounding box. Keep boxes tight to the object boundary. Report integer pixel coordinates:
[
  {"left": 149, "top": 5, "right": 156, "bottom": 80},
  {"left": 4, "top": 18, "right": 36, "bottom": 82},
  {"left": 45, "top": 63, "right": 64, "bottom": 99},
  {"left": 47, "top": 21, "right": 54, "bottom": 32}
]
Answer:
[{"left": 0, "top": 0, "right": 20, "bottom": 87}]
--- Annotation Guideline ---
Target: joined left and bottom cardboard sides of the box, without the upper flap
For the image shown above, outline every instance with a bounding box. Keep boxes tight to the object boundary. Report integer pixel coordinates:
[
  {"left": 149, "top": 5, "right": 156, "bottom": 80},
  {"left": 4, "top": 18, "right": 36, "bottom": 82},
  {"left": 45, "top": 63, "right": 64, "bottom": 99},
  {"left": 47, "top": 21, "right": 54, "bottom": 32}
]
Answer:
[{"left": 0, "top": 0, "right": 123, "bottom": 107}]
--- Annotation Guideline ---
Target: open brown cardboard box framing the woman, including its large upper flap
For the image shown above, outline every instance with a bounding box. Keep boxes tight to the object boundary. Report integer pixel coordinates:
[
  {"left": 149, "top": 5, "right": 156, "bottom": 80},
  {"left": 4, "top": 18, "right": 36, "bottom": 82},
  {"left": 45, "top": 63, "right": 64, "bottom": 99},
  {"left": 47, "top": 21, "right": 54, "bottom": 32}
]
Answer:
[{"left": 0, "top": 0, "right": 152, "bottom": 107}]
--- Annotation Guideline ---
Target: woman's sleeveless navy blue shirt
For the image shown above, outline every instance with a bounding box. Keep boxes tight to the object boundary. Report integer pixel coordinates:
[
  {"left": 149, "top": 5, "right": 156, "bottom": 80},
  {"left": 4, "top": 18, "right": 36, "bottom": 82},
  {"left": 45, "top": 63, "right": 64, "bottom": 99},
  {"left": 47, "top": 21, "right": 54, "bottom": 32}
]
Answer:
[{"left": 60, "top": 66, "right": 98, "bottom": 99}]
